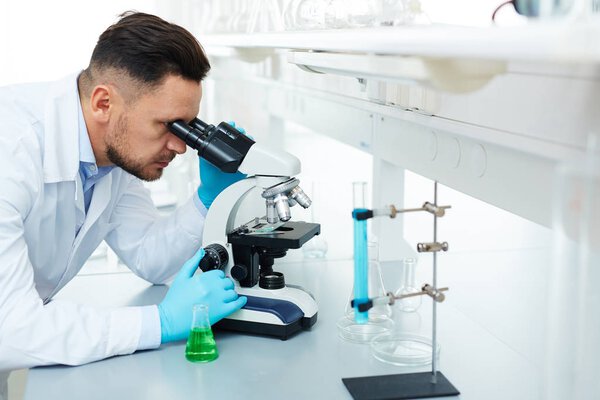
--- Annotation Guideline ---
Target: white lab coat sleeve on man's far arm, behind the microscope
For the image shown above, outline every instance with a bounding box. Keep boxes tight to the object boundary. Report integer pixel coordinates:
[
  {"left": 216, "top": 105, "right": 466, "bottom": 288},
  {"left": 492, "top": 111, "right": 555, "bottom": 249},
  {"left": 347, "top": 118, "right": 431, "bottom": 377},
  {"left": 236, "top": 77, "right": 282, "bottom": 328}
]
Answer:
[{"left": 105, "top": 175, "right": 204, "bottom": 283}]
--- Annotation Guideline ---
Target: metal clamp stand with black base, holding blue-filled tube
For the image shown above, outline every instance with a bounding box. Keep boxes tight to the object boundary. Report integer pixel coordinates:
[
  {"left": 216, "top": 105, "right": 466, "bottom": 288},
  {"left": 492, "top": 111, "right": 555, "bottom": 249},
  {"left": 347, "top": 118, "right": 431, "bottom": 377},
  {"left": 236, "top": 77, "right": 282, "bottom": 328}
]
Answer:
[{"left": 342, "top": 181, "right": 460, "bottom": 400}]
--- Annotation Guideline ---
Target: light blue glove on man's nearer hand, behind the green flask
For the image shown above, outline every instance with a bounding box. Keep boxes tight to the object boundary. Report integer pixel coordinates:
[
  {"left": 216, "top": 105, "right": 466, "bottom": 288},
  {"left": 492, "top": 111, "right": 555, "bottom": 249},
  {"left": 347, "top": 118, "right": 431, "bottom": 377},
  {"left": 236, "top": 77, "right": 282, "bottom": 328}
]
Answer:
[{"left": 158, "top": 249, "right": 247, "bottom": 343}]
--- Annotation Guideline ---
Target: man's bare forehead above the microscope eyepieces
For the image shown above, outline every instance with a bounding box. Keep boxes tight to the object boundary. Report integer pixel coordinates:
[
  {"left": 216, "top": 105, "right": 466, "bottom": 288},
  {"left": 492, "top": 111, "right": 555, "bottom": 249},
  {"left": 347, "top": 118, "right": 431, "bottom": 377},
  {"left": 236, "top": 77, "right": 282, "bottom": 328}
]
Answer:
[{"left": 136, "top": 75, "right": 202, "bottom": 121}]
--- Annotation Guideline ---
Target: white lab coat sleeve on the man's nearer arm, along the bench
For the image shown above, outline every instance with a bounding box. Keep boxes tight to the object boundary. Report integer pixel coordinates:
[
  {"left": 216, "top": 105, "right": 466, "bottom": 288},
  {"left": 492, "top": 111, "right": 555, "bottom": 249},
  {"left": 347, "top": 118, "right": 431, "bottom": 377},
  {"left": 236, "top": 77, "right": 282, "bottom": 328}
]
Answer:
[{"left": 0, "top": 137, "right": 142, "bottom": 371}]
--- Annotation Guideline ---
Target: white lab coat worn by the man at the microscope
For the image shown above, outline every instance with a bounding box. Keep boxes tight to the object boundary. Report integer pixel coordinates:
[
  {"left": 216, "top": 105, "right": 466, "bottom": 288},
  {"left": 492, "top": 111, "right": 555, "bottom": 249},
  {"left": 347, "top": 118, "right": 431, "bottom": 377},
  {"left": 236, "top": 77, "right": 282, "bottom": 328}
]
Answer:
[{"left": 0, "top": 76, "right": 204, "bottom": 372}]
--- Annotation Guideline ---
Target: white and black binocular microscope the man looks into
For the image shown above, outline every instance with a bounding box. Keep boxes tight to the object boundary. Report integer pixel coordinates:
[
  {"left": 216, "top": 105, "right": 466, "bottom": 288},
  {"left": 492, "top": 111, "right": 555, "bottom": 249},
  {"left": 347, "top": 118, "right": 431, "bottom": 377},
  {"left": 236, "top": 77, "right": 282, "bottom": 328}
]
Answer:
[{"left": 168, "top": 118, "right": 321, "bottom": 340}]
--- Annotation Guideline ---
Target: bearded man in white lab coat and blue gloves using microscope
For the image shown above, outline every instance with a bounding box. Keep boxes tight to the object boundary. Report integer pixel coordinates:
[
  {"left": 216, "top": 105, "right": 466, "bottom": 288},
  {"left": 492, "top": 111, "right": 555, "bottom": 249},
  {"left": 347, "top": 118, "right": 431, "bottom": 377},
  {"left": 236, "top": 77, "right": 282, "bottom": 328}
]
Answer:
[{"left": 0, "top": 8, "right": 246, "bottom": 378}]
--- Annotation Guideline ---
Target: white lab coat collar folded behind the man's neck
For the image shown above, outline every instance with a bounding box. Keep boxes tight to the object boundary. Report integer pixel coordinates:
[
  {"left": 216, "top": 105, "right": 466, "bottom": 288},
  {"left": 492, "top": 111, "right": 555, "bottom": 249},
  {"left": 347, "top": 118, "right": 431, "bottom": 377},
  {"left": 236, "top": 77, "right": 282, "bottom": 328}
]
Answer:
[{"left": 44, "top": 74, "right": 79, "bottom": 183}]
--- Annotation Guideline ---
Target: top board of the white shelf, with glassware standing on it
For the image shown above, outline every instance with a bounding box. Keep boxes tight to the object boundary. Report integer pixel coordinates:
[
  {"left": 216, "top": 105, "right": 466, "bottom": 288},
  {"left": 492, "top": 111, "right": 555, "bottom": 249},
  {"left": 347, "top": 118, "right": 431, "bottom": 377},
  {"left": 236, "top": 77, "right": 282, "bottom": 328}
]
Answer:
[{"left": 199, "top": 22, "right": 600, "bottom": 63}]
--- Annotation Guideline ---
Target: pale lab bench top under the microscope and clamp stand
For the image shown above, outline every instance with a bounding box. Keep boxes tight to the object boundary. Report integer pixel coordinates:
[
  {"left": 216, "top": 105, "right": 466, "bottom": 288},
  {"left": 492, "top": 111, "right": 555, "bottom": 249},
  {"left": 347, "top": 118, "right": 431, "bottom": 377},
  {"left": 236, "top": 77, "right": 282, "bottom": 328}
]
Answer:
[{"left": 25, "top": 245, "right": 548, "bottom": 400}]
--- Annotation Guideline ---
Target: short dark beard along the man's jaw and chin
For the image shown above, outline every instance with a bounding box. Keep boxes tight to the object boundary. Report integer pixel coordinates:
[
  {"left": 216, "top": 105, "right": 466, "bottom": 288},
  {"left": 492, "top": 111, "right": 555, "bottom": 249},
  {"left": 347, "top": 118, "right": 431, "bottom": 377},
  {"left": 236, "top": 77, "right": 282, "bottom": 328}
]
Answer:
[{"left": 105, "top": 115, "right": 175, "bottom": 182}]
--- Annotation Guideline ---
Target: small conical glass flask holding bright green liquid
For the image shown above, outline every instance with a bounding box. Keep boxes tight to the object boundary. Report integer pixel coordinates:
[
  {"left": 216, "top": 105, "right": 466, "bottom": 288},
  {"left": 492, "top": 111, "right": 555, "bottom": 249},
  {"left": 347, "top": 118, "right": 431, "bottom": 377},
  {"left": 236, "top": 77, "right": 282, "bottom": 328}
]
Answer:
[{"left": 185, "top": 304, "right": 219, "bottom": 362}]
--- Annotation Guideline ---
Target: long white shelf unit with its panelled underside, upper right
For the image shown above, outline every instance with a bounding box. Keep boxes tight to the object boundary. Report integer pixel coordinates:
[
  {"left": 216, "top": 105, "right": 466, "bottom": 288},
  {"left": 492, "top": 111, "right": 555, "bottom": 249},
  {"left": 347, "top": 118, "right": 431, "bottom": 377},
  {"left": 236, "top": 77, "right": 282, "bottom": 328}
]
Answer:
[{"left": 200, "top": 22, "right": 600, "bottom": 226}]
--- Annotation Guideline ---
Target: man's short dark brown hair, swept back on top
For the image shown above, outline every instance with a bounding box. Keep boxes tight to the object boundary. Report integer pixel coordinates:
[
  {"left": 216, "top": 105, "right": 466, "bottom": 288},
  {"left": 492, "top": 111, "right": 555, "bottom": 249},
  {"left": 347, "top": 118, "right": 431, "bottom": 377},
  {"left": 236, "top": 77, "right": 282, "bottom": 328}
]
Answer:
[{"left": 85, "top": 11, "right": 210, "bottom": 86}]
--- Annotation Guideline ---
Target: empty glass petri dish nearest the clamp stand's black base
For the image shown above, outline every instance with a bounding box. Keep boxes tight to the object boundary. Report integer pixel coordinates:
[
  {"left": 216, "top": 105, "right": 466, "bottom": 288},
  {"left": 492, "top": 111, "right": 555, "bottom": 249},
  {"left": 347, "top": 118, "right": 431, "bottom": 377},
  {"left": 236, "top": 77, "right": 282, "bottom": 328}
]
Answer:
[{"left": 371, "top": 332, "right": 440, "bottom": 366}]
